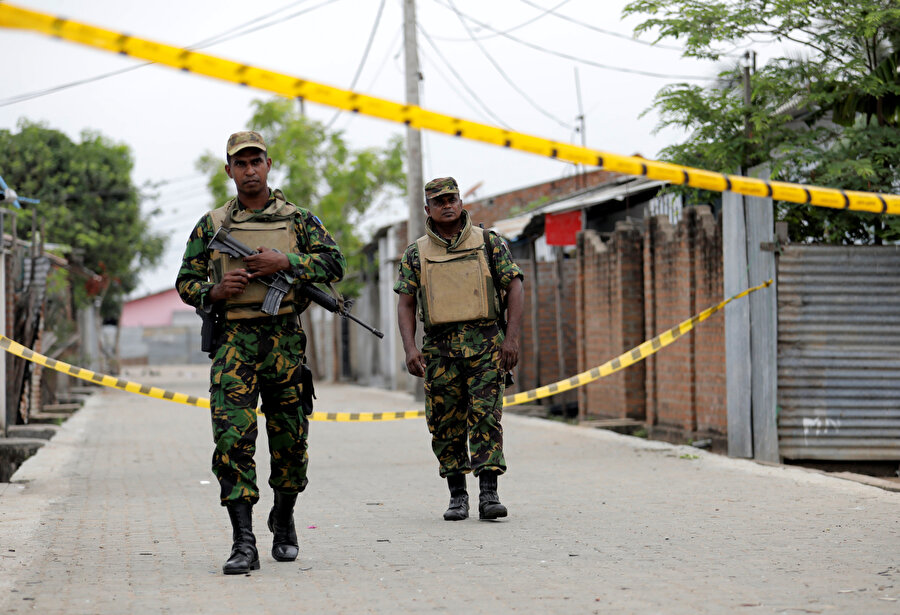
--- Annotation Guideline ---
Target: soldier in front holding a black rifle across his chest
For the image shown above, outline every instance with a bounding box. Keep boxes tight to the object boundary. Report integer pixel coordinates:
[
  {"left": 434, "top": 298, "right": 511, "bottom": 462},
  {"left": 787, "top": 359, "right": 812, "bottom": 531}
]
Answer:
[{"left": 175, "top": 131, "right": 345, "bottom": 574}]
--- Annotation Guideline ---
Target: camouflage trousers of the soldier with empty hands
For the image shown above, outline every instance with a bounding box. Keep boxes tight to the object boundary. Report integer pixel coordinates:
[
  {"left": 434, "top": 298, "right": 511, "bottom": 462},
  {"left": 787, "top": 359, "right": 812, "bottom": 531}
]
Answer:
[{"left": 425, "top": 349, "right": 506, "bottom": 477}]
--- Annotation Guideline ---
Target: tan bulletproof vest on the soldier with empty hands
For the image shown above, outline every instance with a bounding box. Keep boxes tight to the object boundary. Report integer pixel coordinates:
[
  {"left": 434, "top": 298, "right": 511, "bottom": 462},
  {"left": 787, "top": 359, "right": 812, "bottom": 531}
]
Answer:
[{"left": 416, "top": 218, "right": 500, "bottom": 328}]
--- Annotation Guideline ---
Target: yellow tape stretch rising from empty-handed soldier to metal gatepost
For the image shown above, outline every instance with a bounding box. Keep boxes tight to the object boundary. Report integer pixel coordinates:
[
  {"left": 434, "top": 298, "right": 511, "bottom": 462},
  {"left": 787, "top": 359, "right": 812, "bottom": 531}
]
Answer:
[{"left": 503, "top": 280, "right": 772, "bottom": 406}]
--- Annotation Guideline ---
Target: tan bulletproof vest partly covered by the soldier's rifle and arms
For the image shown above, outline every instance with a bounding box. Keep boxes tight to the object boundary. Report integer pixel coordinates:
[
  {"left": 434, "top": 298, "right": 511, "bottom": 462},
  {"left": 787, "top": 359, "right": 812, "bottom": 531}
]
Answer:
[{"left": 209, "top": 190, "right": 297, "bottom": 320}]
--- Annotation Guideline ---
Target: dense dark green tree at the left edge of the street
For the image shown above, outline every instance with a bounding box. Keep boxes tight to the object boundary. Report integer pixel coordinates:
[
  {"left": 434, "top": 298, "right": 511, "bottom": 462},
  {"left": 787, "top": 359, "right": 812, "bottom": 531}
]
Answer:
[{"left": 0, "top": 120, "right": 165, "bottom": 318}]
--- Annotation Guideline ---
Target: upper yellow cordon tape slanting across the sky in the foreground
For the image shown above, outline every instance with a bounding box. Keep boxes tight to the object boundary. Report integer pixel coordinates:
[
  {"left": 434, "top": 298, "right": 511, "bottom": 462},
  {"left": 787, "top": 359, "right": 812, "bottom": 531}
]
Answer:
[{"left": 0, "top": 2, "right": 900, "bottom": 214}]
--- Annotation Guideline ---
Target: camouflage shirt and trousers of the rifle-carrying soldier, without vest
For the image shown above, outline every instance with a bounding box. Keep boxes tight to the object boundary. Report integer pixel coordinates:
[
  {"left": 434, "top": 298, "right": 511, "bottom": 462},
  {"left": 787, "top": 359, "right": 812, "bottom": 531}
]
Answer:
[{"left": 175, "top": 191, "right": 345, "bottom": 506}]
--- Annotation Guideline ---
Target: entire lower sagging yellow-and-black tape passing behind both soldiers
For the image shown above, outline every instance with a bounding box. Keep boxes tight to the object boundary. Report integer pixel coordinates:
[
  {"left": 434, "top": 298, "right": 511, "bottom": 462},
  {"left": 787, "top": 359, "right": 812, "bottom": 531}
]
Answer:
[{"left": 0, "top": 280, "right": 772, "bottom": 423}]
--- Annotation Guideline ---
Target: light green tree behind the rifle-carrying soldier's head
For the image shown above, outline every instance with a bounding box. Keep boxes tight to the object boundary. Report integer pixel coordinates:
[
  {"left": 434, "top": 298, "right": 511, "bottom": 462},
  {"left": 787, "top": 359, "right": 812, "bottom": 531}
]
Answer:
[{"left": 197, "top": 98, "right": 406, "bottom": 295}]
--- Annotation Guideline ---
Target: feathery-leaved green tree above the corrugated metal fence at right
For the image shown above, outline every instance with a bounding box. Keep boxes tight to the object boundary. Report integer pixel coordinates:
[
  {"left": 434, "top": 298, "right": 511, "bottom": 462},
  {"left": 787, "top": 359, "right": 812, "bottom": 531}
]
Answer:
[{"left": 625, "top": 0, "right": 900, "bottom": 243}]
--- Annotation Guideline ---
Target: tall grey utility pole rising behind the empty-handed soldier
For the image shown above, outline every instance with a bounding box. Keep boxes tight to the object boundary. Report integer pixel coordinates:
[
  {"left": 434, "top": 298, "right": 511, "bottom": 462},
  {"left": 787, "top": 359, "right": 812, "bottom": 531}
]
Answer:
[{"left": 403, "top": 0, "right": 425, "bottom": 243}]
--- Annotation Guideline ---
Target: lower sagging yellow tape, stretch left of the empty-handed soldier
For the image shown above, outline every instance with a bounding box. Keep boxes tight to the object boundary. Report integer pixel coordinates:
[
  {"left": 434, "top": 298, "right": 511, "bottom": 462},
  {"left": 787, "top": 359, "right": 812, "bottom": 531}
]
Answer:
[{"left": 0, "top": 335, "right": 425, "bottom": 423}]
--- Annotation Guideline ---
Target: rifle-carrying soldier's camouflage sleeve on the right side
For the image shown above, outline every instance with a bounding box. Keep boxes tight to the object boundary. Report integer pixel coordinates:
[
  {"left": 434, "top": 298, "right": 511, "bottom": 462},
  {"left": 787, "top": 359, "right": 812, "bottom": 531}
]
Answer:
[{"left": 288, "top": 207, "right": 347, "bottom": 283}]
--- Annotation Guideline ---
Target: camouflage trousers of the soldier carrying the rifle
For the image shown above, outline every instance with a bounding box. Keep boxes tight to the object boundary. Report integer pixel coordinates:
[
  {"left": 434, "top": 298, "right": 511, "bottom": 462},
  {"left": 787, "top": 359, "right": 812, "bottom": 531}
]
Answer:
[{"left": 209, "top": 315, "right": 309, "bottom": 506}]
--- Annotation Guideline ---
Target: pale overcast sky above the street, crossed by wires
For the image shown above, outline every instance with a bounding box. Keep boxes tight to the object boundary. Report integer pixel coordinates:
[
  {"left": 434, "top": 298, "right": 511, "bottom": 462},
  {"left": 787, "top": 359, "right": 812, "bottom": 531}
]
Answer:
[{"left": 0, "top": 0, "right": 736, "bottom": 296}]
